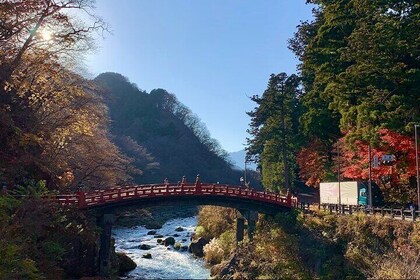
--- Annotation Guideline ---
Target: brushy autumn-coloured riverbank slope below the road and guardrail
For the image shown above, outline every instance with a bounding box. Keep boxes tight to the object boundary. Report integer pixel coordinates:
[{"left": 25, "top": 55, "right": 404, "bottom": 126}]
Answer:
[{"left": 199, "top": 208, "right": 420, "bottom": 279}]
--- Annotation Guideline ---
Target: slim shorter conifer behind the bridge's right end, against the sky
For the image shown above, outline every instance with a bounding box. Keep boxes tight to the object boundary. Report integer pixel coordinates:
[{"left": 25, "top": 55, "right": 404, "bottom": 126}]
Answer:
[{"left": 247, "top": 73, "right": 300, "bottom": 190}]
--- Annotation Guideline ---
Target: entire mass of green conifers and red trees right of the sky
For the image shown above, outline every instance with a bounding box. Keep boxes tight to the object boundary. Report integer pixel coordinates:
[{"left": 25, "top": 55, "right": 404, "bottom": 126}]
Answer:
[{"left": 248, "top": 0, "right": 420, "bottom": 202}]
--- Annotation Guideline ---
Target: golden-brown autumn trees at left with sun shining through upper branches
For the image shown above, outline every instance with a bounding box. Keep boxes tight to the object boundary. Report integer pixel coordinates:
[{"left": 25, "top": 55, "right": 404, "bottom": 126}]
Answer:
[{"left": 0, "top": 0, "right": 130, "bottom": 190}]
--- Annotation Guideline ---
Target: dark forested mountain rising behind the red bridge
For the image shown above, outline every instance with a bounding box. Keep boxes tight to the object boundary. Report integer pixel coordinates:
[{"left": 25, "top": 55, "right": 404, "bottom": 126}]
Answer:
[{"left": 95, "top": 73, "right": 241, "bottom": 184}]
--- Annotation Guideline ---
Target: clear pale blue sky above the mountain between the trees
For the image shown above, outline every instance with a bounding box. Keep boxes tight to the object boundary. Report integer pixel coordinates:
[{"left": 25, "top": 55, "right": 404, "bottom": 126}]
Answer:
[{"left": 86, "top": 0, "right": 312, "bottom": 152}]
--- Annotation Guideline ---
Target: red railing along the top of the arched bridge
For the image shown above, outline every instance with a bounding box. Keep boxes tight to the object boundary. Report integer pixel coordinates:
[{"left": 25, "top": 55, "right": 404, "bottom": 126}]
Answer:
[{"left": 56, "top": 182, "right": 298, "bottom": 208}]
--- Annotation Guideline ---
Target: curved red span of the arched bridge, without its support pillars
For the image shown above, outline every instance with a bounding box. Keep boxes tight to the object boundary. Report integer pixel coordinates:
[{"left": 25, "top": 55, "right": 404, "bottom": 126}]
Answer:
[{"left": 56, "top": 182, "right": 298, "bottom": 214}]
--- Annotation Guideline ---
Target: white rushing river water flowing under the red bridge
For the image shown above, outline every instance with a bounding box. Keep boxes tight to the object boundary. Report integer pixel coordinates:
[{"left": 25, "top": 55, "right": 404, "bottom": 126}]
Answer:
[{"left": 112, "top": 217, "right": 210, "bottom": 279}]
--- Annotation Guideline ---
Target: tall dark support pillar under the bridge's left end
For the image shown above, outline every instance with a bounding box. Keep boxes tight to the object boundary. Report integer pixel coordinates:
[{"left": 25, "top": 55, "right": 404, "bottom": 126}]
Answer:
[{"left": 99, "top": 214, "right": 116, "bottom": 277}]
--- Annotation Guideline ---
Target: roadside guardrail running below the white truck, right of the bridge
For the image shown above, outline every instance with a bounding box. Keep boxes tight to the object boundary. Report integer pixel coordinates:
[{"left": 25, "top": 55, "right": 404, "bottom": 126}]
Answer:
[{"left": 299, "top": 203, "right": 420, "bottom": 222}]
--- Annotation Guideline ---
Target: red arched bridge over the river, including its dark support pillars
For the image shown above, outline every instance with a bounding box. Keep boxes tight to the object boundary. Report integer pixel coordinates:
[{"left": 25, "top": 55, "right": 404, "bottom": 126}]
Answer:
[{"left": 55, "top": 177, "right": 298, "bottom": 276}]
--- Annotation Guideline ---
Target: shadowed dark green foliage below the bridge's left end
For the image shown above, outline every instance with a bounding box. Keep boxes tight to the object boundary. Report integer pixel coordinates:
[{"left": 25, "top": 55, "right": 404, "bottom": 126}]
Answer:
[{"left": 0, "top": 190, "right": 97, "bottom": 279}]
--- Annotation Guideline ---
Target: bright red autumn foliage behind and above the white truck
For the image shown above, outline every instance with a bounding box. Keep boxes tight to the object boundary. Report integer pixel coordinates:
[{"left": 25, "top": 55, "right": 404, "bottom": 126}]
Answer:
[{"left": 297, "top": 129, "right": 416, "bottom": 201}]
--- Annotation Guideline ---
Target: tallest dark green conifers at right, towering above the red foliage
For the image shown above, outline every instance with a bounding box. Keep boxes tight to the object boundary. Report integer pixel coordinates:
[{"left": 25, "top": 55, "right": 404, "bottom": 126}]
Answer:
[{"left": 289, "top": 0, "right": 420, "bottom": 203}]
